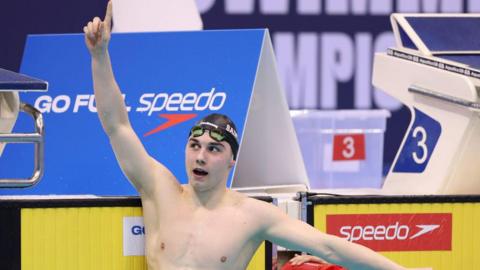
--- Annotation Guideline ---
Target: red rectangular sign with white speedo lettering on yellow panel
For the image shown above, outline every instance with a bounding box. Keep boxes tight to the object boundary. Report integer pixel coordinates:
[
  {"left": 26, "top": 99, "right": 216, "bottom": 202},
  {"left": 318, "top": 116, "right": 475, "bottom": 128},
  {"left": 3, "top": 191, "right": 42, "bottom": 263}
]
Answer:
[{"left": 327, "top": 213, "right": 452, "bottom": 251}]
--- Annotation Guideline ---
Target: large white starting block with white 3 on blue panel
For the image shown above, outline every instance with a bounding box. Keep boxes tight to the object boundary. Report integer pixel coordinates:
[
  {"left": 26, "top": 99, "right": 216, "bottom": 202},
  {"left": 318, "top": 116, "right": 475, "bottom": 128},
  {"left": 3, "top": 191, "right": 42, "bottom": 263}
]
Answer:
[{"left": 373, "top": 14, "right": 480, "bottom": 194}]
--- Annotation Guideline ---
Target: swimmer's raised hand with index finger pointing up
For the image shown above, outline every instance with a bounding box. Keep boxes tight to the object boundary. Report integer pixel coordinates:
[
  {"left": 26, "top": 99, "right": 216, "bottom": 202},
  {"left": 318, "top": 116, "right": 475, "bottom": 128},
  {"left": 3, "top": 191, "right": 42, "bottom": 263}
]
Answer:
[{"left": 83, "top": 1, "right": 112, "bottom": 57}]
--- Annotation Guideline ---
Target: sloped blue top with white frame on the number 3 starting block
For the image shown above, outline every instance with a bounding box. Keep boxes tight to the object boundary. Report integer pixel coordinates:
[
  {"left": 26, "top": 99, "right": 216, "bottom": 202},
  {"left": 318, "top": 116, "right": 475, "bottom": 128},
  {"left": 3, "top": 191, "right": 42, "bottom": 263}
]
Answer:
[{"left": 389, "top": 14, "right": 480, "bottom": 79}]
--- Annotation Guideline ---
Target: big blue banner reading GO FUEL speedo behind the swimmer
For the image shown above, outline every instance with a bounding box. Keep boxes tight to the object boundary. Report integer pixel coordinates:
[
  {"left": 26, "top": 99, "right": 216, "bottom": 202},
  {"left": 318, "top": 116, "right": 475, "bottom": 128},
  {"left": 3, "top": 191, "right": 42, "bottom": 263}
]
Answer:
[{"left": 0, "top": 30, "right": 265, "bottom": 195}]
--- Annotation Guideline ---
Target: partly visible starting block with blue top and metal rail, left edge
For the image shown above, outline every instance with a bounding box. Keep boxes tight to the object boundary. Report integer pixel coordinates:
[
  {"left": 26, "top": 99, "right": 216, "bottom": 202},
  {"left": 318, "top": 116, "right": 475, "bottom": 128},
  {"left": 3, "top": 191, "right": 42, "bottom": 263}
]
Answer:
[{"left": 0, "top": 69, "right": 48, "bottom": 187}]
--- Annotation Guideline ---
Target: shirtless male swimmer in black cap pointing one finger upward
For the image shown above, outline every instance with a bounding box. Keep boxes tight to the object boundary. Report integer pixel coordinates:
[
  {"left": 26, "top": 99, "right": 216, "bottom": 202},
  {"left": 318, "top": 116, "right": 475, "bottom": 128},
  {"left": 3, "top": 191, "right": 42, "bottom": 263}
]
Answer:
[{"left": 83, "top": 3, "right": 403, "bottom": 270}]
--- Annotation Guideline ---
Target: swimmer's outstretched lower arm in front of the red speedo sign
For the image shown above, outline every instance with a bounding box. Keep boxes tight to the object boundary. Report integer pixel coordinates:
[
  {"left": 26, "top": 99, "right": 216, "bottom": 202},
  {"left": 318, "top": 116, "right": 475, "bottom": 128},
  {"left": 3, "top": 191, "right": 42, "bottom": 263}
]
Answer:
[{"left": 258, "top": 205, "right": 404, "bottom": 270}]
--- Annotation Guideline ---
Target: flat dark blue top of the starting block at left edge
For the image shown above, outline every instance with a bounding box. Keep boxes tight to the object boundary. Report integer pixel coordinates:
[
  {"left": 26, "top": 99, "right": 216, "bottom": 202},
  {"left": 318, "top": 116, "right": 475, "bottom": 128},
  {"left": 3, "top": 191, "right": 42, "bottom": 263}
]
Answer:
[{"left": 0, "top": 68, "right": 48, "bottom": 92}]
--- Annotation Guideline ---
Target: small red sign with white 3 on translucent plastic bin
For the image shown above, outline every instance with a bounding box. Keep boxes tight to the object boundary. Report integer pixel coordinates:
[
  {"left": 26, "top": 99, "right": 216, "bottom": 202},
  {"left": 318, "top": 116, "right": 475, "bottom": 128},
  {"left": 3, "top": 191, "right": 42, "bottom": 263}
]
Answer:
[{"left": 333, "top": 134, "right": 365, "bottom": 161}]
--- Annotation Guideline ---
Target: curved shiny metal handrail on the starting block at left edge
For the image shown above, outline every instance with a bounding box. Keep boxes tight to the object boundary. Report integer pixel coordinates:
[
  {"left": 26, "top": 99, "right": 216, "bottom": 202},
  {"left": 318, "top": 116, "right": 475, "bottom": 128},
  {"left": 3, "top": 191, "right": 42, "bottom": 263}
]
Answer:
[{"left": 0, "top": 103, "right": 45, "bottom": 188}]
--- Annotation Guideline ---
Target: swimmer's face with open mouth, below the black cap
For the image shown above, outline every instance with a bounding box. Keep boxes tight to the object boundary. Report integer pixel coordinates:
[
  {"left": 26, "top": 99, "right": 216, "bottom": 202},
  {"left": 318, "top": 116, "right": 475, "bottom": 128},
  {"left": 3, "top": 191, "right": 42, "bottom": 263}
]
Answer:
[{"left": 185, "top": 132, "right": 235, "bottom": 191}]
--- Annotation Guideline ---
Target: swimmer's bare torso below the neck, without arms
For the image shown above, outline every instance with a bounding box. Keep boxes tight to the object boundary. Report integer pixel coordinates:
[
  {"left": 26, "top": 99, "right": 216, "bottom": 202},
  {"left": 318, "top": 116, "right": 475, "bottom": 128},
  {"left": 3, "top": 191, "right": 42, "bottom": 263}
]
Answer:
[{"left": 143, "top": 187, "right": 261, "bottom": 270}]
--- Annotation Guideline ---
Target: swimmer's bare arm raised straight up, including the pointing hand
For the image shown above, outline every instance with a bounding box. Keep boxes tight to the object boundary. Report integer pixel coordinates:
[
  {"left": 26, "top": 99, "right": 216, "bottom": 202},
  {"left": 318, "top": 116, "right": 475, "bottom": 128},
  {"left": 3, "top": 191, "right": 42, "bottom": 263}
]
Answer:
[{"left": 83, "top": 1, "right": 181, "bottom": 197}]
